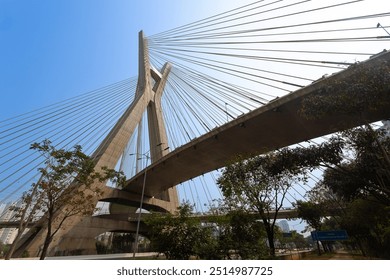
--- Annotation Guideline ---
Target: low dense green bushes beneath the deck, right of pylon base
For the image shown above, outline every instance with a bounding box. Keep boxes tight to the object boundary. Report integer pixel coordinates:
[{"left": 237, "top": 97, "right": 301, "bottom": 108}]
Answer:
[{"left": 146, "top": 204, "right": 269, "bottom": 260}]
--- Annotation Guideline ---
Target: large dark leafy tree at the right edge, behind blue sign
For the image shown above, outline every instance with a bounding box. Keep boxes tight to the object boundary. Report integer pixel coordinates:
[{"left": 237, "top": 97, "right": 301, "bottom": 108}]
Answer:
[{"left": 296, "top": 125, "right": 390, "bottom": 258}]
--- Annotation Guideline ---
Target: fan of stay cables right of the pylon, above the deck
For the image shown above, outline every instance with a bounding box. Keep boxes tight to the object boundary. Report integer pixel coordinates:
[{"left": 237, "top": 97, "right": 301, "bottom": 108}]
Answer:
[{"left": 143, "top": 1, "right": 390, "bottom": 211}]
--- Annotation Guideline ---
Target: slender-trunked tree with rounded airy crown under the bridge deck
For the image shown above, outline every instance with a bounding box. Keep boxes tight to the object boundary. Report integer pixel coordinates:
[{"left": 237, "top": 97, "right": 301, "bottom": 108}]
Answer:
[{"left": 218, "top": 152, "right": 299, "bottom": 256}]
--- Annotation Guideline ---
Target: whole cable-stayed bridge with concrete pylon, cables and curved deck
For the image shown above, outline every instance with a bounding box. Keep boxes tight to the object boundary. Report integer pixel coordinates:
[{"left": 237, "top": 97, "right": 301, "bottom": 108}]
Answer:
[{"left": 0, "top": 1, "right": 390, "bottom": 254}]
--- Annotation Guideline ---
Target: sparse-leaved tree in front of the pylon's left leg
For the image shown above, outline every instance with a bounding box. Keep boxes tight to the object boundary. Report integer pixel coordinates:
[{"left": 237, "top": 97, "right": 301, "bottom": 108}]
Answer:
[{"left": 7, "top": 140, "right": 125, "bottom": 259}]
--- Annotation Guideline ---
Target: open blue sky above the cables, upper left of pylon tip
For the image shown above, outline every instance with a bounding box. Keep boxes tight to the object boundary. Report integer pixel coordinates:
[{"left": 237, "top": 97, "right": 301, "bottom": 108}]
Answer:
[{"left": 0, "top": 0, "right": 251, "bottom": 120}]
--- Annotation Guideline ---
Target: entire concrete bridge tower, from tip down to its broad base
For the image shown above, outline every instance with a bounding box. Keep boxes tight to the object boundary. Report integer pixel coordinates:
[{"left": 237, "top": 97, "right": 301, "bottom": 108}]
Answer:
[{"left": 14, "top": 31, "right": 179, "bottom": 256}]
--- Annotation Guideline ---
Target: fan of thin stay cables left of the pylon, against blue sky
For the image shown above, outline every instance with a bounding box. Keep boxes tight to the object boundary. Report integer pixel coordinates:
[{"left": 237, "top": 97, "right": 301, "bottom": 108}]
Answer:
[{"left": 0, "top": 78, "right": 137, "bottom": 203}]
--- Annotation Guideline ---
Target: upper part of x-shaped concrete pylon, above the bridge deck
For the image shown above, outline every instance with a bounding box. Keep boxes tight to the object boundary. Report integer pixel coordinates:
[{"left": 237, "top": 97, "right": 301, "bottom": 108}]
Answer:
[{"left": 93, "top": 31, "right": 171, "bottom": 170}]
